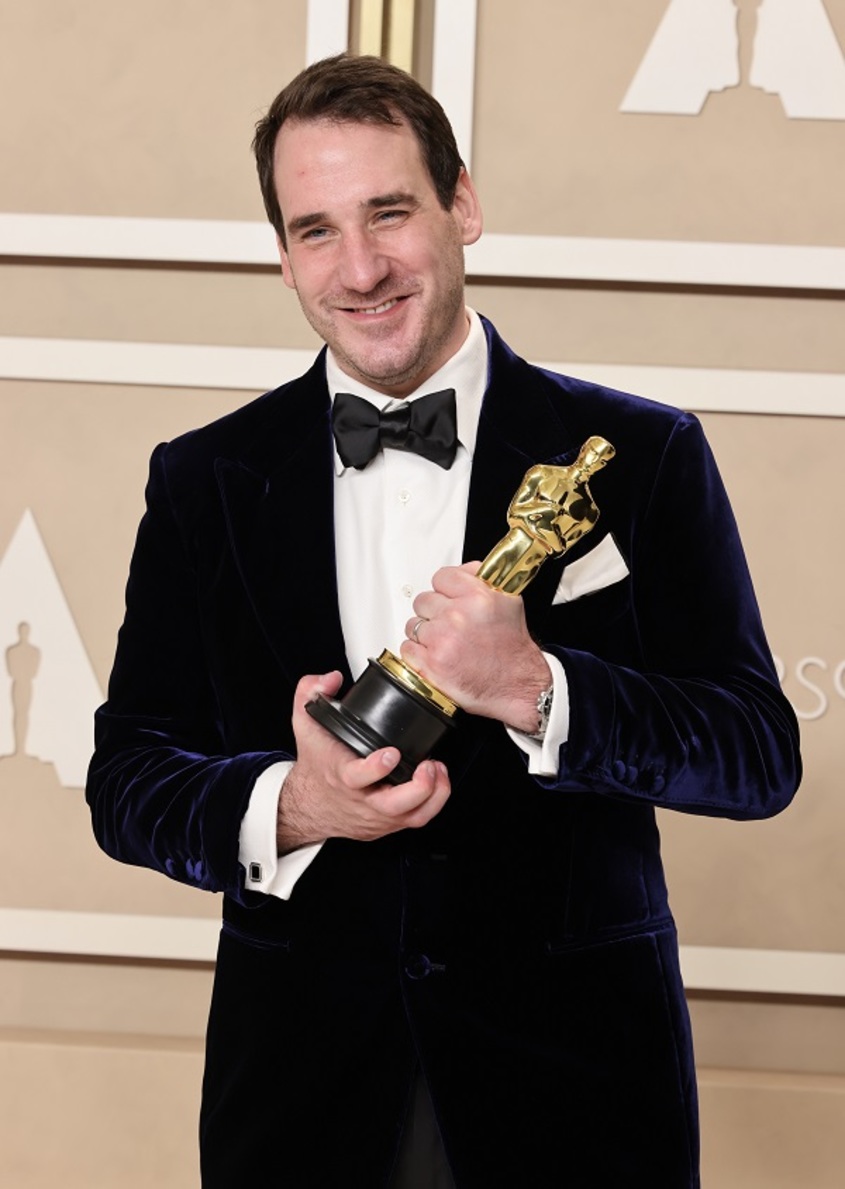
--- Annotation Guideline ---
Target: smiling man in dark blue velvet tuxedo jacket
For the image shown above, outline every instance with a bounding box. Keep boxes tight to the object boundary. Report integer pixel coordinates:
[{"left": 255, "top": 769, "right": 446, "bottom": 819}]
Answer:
[{"left": 88, "top": 57, "right": 799, "bottom": 1189}]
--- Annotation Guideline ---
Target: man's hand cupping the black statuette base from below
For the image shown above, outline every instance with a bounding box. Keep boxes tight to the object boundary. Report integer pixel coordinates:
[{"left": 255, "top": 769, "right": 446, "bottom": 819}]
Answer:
[{"left": 277, "top": 672, "right": 452, "bottom": 855}]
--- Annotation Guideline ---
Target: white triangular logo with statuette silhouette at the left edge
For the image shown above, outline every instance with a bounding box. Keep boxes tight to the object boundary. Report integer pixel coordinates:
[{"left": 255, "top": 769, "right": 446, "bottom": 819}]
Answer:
[{"left": 0, "top": 509, "right": 102, "bottom": 788}]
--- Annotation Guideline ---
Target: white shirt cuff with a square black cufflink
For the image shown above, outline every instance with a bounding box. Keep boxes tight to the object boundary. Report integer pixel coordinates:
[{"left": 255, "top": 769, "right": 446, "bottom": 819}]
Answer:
[{"left": 238, "top": 760, "right": 322, "bottom": 900}]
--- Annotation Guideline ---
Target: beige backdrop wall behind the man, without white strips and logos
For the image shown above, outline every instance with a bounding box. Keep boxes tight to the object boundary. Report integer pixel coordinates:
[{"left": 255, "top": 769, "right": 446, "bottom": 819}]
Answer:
[{"left": 0, "top": 0, "right": 845, "bottom": 1189}]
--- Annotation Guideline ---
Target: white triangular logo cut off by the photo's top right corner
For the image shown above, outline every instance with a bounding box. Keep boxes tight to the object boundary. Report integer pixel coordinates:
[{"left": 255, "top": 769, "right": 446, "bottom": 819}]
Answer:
[{"left": 619, "top": 0, "right": 845, "bottom": 120}]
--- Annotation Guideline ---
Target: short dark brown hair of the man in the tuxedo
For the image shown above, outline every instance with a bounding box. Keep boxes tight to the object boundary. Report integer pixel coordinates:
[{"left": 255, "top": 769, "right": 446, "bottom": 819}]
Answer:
[{"left": 252, "top": 54, "right": 464, "bottom": 244}]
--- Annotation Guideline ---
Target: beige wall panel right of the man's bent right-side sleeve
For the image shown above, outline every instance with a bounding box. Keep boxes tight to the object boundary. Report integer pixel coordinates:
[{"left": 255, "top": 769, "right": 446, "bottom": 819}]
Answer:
[{"left": 661, "top": 414, "right": 845, "bottom": 955}]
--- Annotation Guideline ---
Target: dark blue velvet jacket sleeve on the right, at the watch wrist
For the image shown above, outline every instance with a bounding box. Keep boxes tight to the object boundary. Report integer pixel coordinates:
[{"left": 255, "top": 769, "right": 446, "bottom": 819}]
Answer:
[{"left": 542, "top": 414, "right": 801, "bottom": 818}]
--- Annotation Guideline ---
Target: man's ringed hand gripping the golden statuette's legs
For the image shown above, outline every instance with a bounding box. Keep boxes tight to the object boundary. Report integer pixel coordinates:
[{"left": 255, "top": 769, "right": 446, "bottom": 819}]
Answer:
[{"left": 399, "top": 561, "right": 551, "bottom": 734}]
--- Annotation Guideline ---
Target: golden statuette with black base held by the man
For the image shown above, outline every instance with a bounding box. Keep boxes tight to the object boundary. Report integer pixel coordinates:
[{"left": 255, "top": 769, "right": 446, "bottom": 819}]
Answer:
[{"left": 305, "top": 435, "right": 616, "bottom": 785}]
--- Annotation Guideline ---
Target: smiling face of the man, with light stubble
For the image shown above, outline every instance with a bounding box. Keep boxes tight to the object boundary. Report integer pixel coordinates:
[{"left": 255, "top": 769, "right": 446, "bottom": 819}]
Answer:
[{"left": 275, "top": 120, "right": 481, "bottom": 396}]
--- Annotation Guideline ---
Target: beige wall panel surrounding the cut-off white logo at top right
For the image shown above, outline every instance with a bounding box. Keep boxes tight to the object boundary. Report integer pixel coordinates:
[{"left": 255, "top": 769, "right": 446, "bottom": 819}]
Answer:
[{"left": 474, "top": 0, "right": 845, "bottom": 246}]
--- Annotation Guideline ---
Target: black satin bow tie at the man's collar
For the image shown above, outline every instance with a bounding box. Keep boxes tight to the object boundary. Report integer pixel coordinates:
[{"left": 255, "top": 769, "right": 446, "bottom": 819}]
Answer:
[{"left": 332, "top": 388, "right": 458, "bottom": 471}]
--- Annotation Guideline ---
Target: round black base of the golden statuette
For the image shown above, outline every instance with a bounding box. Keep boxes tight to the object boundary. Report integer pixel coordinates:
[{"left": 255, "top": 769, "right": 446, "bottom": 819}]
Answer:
[{"left": 305, "top": 660, "right": 454, "bottom": 785}]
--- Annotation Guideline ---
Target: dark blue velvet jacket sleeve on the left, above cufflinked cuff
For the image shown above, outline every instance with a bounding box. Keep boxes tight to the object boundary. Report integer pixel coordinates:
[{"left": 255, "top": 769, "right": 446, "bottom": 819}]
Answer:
[{"left": 86, "top": 446, "right": 291, "bottom": 894}]
